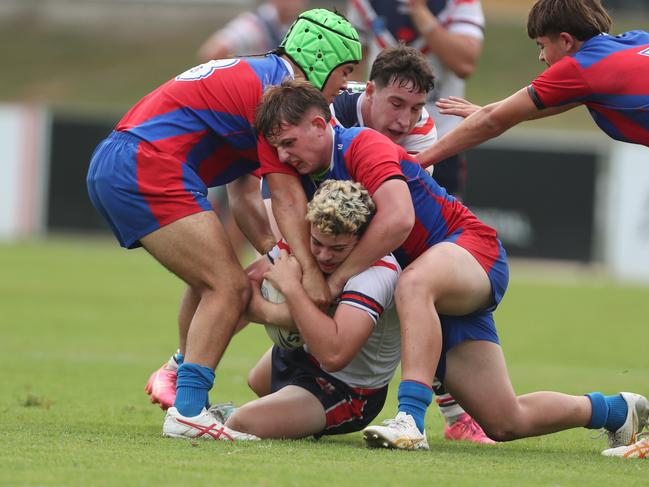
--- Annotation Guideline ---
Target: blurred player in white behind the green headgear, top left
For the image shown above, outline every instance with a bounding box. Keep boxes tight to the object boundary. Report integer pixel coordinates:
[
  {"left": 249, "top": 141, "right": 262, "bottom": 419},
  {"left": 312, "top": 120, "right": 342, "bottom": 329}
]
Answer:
[{"left": 198, "top": 0, "right": 309, "bottom": 62}]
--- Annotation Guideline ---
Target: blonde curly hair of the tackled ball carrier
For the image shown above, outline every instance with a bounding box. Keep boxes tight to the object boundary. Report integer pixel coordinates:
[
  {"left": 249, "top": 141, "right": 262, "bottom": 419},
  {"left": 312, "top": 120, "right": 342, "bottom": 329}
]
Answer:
[{"left": 306, "top": 179, "right": 376, "bottom": 238}]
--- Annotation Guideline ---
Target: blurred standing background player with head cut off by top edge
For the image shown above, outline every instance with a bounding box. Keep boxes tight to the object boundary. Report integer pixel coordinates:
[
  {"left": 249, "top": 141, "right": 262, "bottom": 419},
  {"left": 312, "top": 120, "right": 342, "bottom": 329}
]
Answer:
[{"left": 347, "top": 0, "right": 485, "bottom": 197}]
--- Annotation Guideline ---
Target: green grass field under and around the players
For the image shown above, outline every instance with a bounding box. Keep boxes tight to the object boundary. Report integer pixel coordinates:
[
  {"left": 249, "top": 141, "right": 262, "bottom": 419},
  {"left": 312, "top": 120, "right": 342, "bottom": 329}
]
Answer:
[{"left": 0, "top": 238, "right": 649, "bottom": 486}]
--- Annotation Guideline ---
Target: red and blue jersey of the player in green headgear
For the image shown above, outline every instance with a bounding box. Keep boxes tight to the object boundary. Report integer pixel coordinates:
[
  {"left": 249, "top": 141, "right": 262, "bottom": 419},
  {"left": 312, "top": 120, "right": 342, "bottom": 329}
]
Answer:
[{"left": 116, "top": 55, "right": 293, "bottom": 187}]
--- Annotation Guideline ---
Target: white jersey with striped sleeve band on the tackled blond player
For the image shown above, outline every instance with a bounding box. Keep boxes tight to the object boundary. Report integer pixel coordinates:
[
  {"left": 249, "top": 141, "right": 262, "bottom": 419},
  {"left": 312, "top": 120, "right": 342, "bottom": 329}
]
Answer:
[{"left": 269, "top": 241, "right": 401, "bottom": 389}]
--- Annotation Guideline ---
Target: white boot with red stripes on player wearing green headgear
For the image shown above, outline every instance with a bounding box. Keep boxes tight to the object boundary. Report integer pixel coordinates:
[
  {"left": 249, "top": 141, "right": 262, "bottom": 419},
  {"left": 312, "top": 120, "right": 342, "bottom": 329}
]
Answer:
[{"left": 162, "top": 407, "right": 259, "bottom": 441}]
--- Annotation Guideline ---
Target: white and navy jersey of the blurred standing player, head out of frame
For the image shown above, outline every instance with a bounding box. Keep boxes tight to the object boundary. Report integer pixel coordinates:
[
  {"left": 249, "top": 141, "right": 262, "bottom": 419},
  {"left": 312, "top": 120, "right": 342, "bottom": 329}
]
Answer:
[{"left": 347, "top": 0, "right": 485, "bottom": 137}]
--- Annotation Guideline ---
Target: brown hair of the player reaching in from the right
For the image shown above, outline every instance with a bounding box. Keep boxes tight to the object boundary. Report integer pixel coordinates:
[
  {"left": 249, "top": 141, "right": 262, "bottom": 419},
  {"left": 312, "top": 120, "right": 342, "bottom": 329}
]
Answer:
[{"left": 527, "top": 0, "right": 612, "bottom": 41}]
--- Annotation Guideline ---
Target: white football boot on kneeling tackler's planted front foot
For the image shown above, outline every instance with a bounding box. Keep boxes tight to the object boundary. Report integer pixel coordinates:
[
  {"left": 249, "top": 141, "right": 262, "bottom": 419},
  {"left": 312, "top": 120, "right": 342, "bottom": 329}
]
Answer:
[{"left": 363, "top": 412, "right": 429, "bottom": 450}]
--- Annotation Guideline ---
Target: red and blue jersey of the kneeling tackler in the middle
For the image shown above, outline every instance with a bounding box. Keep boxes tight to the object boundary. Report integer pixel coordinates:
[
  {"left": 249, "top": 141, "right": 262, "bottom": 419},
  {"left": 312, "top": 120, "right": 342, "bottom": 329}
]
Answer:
[{"left": 302, "top": 125, "right": 500, "bottom": 272}]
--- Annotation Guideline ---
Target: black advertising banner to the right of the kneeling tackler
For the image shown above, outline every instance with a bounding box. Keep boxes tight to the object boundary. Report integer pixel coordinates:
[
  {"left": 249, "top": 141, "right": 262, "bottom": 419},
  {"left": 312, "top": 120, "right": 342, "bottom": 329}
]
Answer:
[{"left": 464, "top": 147, "right": 598, "bottom": 262}]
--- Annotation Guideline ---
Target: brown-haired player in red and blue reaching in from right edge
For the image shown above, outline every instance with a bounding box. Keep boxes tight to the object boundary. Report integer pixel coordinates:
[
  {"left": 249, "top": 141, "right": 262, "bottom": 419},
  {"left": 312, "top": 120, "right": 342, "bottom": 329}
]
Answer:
[{"left": 418, "top": 0, "right": 649, "bottom": 170}]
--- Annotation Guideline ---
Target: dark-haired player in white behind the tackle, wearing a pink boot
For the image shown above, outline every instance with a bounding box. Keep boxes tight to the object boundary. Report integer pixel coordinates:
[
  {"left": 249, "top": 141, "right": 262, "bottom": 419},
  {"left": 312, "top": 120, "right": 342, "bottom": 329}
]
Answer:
[{"left": 331, "top": 44, "right": 494, "bottom": 444}]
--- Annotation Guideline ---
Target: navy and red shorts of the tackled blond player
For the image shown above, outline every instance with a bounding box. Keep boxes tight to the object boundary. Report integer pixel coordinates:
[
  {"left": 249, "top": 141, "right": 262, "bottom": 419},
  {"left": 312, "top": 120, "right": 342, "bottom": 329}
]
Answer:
[{"left": 271, "top": 346, "right": 388, "bottom": 438}]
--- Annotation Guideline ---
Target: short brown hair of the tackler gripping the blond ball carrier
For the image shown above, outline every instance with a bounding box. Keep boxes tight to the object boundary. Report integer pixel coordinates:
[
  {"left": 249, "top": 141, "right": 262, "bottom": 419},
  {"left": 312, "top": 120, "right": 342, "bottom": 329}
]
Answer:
[{"left": 254, "top": 79, "right": 331, "bottom": 139}]
